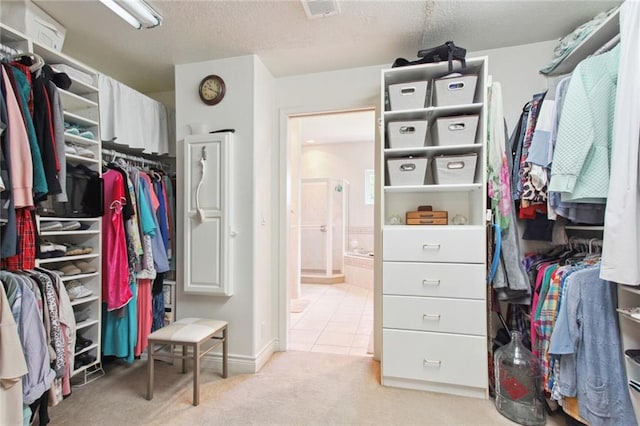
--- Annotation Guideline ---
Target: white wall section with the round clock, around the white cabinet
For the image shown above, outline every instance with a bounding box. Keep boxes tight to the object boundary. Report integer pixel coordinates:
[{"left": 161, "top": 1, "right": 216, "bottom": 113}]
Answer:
[{"left": 175, "top": 55, "right": 273, "bottom": 371}]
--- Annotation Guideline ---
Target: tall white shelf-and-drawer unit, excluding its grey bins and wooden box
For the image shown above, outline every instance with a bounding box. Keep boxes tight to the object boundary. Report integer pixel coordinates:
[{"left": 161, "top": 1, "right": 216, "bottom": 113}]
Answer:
[{"left": 376, "top": 58, "right": 488, "bottom": 398}]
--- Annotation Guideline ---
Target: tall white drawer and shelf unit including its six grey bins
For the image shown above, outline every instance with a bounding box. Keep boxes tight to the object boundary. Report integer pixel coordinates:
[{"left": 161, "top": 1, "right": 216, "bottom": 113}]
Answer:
[{"left": 376, "top": 57, "right": 491, "bottom": 399}]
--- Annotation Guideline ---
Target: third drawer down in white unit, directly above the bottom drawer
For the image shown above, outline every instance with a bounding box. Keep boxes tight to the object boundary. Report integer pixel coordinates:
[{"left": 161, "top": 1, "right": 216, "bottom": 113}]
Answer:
[{"left": 382, "top": 295, "right": 487, "bottom": 336}]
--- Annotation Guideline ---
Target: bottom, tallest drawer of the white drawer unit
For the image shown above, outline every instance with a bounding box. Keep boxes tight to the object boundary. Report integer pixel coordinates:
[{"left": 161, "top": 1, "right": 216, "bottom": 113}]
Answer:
[{"left": 382, "top": 330, "right": 488, "bottom": 389}]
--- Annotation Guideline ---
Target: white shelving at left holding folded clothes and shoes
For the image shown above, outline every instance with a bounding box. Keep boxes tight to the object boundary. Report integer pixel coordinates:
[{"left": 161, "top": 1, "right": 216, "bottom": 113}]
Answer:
[{"left": 0, "top": 23, "right": 104, "bottom": 384}]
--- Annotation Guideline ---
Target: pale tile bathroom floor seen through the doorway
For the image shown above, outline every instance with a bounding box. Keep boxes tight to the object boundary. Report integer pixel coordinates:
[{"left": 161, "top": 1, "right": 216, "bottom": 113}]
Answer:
[{"left": 289, "top": 284, "right": 373, "bottom": 356}]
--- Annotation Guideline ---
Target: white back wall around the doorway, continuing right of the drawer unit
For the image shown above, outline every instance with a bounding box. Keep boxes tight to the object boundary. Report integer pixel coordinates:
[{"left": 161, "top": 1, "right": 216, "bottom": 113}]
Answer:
[{"left": 273, "top": 40, "right": 557, "bottom": 357}]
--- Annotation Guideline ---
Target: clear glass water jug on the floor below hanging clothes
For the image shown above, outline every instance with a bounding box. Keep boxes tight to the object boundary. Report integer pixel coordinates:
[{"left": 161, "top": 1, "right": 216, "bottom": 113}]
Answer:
[{"left": 494, "top": 331, "right": 545, "bottom": 426}]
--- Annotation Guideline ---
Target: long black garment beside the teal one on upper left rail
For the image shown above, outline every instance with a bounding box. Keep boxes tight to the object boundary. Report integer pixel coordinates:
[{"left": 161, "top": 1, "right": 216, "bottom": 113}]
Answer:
[{"left": 32, "top": 65, "right": 64, "bottom": 201}]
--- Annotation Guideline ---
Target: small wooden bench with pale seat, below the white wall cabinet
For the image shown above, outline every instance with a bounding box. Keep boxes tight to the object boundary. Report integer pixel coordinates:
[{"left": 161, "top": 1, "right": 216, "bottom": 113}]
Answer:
[{"left": 147, "top": 318, "right": 228, "bottom": 405}]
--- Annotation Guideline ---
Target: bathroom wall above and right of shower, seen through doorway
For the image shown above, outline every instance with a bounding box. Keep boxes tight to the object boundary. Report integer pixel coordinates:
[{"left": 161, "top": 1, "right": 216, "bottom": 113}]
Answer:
[{"left": 301, "top": 140, "right": 374, "bottom": 251}]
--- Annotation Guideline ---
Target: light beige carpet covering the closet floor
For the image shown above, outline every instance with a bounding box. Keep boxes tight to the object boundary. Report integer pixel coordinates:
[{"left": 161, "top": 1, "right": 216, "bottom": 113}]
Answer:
[{"left": 49, "top": 351, "right": 562, "bottom": 426}]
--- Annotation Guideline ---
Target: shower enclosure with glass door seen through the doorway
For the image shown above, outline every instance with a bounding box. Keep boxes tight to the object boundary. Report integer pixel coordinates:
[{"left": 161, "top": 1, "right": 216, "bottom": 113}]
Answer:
[{"left": 300, "top": 178, "right": 349, "bottom": 283}]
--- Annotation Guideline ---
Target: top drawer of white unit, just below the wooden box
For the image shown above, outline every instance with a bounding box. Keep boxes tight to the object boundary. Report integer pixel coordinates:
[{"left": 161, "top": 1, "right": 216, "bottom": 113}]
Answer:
[{"left": 382, "top": 226, "right": 486, "bottom": 263}]
